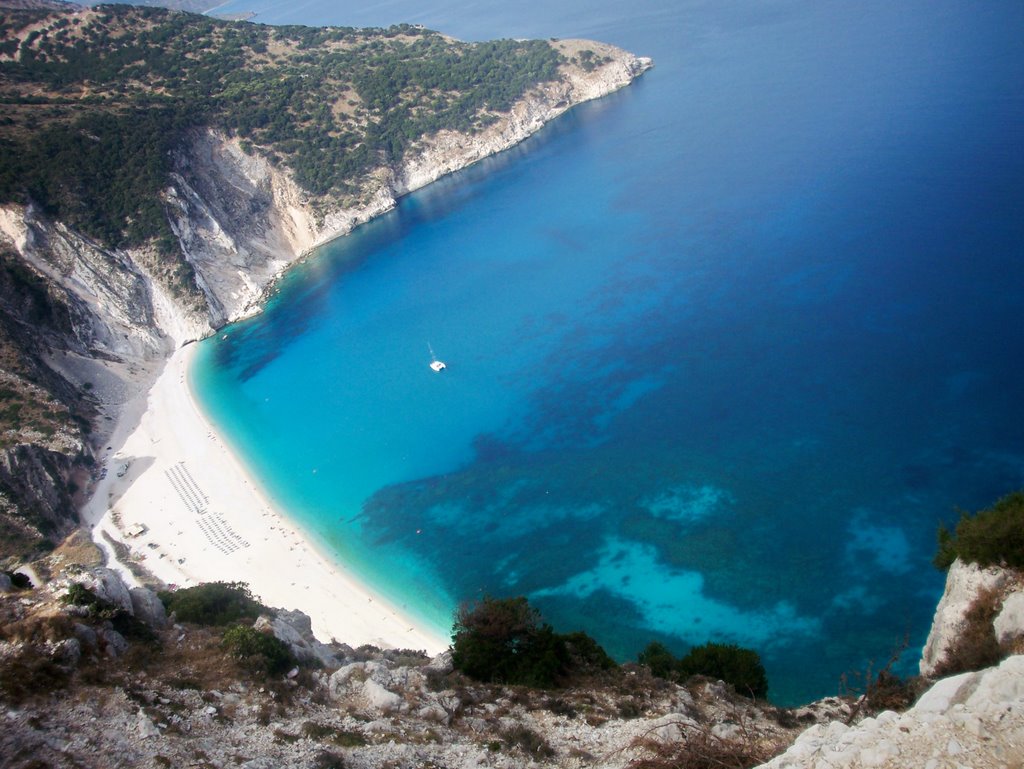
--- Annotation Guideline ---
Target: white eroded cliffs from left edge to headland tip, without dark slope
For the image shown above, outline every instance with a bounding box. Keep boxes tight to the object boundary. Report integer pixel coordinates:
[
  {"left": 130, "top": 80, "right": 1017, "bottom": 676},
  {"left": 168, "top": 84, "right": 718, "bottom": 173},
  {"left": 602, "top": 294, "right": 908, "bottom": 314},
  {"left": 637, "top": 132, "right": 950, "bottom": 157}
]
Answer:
[{"left": 0, "top": 41, "right": 651, "bottom": 456}]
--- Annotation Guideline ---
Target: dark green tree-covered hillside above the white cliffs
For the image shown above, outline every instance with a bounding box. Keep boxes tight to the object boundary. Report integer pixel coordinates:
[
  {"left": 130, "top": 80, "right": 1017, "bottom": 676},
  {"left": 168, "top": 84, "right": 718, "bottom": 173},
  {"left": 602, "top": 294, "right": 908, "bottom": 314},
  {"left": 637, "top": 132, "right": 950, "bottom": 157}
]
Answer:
[{"left": 0, "top": 5, "right": 562, "bottom": 250}]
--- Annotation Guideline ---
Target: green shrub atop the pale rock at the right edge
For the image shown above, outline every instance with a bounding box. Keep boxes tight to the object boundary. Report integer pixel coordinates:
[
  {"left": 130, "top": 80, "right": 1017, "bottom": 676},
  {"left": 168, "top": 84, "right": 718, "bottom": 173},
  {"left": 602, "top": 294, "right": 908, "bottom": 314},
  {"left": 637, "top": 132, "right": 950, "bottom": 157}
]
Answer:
[{"left": 933, "top": 492, "right": 1024, "bottom": 570}]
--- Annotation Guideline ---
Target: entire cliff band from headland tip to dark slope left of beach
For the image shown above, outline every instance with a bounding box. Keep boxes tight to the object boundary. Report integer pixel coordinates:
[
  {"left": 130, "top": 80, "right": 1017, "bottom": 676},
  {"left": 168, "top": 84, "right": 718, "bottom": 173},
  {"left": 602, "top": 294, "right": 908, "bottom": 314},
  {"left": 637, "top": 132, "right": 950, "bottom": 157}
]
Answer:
[{"left": 0, "top": 48, "right": 650, "bottom": 556}]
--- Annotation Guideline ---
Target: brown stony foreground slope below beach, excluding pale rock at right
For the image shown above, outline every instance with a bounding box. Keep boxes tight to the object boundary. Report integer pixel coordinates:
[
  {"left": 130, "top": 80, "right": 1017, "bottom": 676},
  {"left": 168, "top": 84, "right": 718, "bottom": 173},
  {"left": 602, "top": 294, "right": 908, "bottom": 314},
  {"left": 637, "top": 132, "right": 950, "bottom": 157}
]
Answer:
[{"left": 0, "top": 566, "right": 815, "bottom": 769}]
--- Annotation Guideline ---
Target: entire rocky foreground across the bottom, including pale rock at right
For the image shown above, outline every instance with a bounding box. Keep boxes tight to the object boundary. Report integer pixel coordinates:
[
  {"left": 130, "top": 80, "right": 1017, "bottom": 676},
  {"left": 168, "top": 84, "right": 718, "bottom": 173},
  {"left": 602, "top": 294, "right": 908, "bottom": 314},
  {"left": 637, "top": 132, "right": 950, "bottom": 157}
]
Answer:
[{"left": 0, "top": 536, "right": 1024, "bottom": 769}]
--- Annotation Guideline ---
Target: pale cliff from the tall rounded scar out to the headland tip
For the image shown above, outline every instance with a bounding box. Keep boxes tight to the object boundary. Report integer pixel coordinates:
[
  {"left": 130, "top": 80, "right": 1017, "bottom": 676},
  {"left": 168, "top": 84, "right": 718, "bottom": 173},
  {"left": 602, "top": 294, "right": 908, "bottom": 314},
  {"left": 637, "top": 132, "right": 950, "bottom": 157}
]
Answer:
[{"left": 167, "top": 41, "right": 651, "bottom": 327}]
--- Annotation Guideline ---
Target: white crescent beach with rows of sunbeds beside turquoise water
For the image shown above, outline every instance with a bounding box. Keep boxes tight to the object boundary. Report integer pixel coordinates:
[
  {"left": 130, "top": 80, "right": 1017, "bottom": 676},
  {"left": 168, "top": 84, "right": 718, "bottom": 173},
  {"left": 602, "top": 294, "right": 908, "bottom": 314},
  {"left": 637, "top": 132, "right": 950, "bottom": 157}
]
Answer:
[{"left": 82, "top": 345, "right": 449, "bottom": 654}]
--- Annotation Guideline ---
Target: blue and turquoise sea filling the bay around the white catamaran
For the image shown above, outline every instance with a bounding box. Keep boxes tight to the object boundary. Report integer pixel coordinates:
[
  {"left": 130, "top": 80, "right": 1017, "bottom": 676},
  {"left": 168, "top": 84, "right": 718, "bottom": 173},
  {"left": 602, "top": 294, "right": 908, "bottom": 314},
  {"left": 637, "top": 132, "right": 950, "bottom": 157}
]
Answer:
[{"left": 194, "top": 0, "right": 1024, "bottom": 703}]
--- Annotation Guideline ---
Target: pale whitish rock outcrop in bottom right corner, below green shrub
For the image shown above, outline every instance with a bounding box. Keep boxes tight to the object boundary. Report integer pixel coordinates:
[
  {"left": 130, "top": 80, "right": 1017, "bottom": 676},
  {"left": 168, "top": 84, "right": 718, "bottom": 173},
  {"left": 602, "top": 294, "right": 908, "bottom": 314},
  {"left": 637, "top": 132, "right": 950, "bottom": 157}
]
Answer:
[{"left": 764, "top": 559, "right": 1024, "bottom": 769}]
